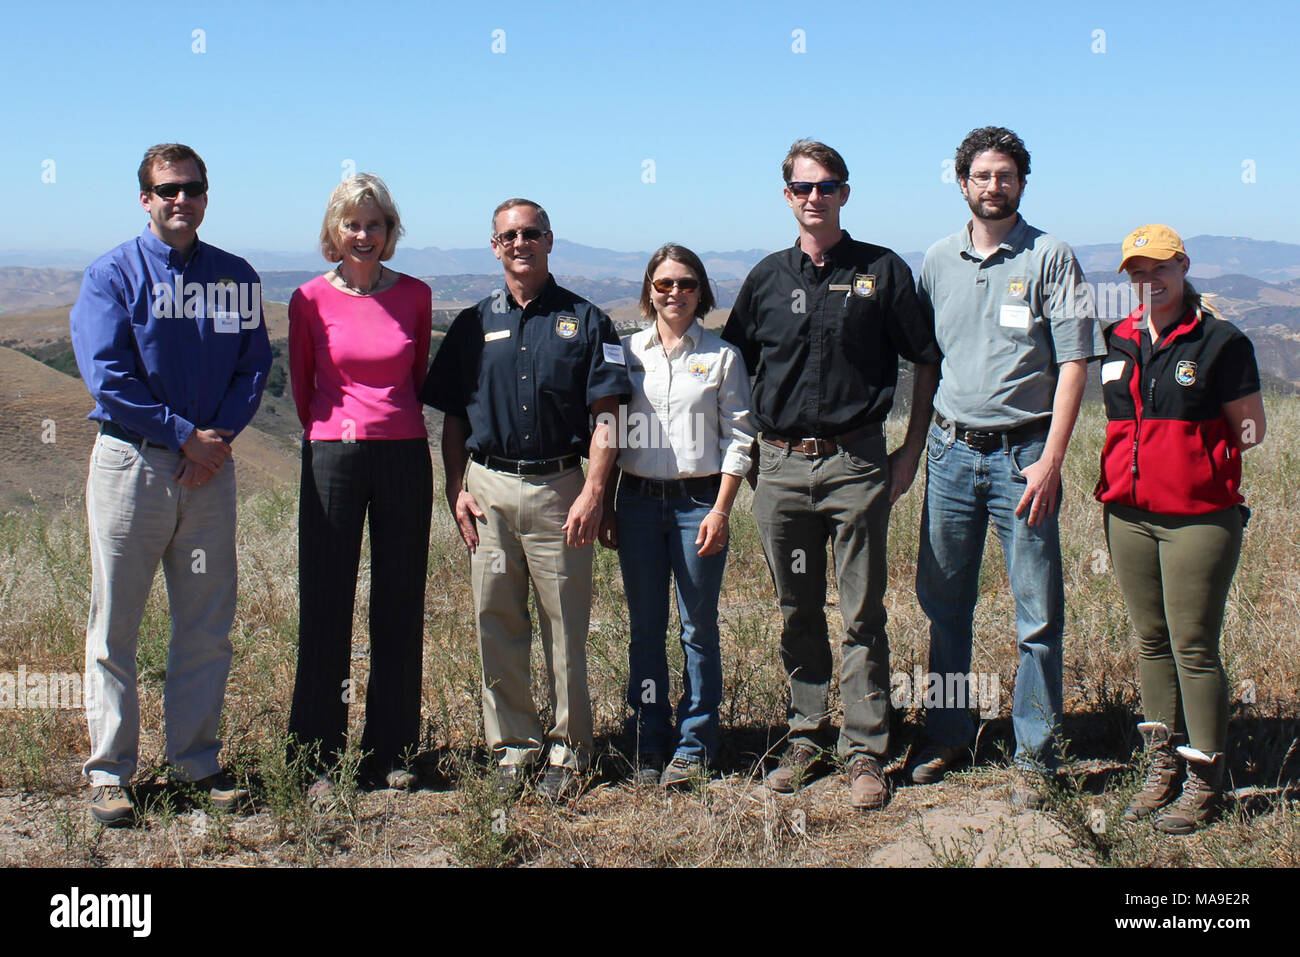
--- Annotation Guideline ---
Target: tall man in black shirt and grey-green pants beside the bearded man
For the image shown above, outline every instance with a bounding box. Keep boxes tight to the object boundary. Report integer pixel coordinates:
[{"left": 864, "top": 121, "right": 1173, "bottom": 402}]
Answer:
[{"left": 723, "top": 140, "right": 940, "bottom": 809}]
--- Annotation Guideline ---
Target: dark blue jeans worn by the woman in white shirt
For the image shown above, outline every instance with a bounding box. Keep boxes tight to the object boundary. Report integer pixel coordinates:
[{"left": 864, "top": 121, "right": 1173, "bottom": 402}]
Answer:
[{"left": 615, "top": 486, "right": 727, "bottom": 765}]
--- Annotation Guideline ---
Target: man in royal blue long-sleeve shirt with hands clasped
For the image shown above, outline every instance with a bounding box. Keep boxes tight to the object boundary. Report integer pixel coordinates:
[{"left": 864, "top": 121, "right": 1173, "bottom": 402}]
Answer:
[{"left": 72, "top": 143, "right": 270, "bottom": 824}]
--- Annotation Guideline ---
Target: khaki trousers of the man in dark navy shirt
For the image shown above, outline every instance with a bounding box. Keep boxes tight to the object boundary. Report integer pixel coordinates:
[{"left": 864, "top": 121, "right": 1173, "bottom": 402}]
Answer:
[{"left": 465, "top": 462, "right": 594, "bottom": 770}]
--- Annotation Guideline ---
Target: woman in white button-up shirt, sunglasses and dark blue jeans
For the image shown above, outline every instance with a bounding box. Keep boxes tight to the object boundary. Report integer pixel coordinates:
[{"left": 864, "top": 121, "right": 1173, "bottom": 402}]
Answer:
[{"left": 601, "top": 243, "right": 754, "bottom": 787}]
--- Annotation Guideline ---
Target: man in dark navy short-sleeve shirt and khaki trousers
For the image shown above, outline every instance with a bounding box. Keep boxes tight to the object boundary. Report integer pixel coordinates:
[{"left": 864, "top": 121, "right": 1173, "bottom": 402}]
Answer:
[{"left": 420, "top": 199, "right": 631, "bottom": 800}]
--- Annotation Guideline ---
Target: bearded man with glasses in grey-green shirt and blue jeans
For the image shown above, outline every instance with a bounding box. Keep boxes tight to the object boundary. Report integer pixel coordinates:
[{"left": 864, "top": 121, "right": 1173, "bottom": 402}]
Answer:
[{"left": 909, "top": 126, "right": 1105, "bottom": 807}]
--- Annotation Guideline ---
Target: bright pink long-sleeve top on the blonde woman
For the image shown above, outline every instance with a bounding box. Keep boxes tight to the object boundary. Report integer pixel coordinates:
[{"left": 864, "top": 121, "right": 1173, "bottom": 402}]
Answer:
[{"left": 289, "top": 276, "right": 433, "bottom": 441}]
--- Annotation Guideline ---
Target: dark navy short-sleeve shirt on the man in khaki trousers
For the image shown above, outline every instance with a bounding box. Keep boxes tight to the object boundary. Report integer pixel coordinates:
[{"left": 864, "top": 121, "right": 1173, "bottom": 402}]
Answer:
[{"left": 420, "top": 277, "right": 632, "bottom": 459}]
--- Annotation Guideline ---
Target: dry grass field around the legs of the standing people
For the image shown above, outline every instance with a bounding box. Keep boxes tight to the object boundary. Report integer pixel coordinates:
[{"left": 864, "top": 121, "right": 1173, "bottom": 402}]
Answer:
[{"left": 0, "top": 395, "right": 1300, "bottom": 867}]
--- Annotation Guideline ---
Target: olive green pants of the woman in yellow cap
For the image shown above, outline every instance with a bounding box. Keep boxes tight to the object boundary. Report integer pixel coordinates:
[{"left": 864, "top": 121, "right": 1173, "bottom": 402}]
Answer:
[{"left": 1105, "top": 505, "right": 1242, "bottom": 754}]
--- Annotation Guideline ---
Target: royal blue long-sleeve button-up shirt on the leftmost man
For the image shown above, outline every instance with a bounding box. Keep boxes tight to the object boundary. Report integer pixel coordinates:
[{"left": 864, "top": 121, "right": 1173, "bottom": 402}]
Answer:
[{"left": 70, "top": 228, "right": 272, "bottom": 451}]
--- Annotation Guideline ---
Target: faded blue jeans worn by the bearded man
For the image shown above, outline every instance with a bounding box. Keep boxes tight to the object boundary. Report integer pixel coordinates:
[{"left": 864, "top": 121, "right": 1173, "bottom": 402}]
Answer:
[{"left": 917, "top": 424, "right": 1065, "bottom": 767}]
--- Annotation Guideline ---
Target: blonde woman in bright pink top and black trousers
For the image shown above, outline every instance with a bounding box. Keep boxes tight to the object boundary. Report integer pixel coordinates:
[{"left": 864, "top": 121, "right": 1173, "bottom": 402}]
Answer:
[{"left": 289, "top": 174, "right": 433, "bottom": 797}]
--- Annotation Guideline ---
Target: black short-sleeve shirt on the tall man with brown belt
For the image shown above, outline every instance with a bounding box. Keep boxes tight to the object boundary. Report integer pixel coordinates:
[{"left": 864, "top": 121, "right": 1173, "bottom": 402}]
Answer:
[{"left": 723, "top": 233, "right": 941, "bottom": 438}]
